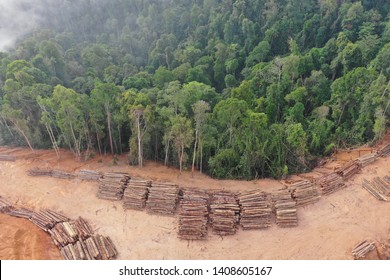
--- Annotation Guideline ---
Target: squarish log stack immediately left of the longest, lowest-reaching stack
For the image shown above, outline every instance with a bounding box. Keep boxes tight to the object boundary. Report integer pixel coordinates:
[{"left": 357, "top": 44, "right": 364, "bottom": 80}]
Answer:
[{"left": 146, "top": 182, "right": 179, "bottom": 215}]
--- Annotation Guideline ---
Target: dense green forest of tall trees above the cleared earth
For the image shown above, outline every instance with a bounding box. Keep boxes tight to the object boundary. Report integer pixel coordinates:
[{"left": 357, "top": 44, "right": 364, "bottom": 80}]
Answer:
[{"left": 0, "top": 0, "right": 390, "bottom": 179}]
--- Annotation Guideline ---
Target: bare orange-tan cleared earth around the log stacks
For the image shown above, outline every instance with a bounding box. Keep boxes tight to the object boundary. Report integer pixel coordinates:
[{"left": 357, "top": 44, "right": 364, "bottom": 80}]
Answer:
[{"left": 0, "top": 137, "right": 390, "bottom": 260}]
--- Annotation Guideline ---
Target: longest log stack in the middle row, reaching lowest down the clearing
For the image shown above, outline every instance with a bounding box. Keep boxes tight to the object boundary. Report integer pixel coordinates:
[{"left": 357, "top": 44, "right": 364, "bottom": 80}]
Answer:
[{"left": 178, "top": 189, "right": 210, "bottom": 240}]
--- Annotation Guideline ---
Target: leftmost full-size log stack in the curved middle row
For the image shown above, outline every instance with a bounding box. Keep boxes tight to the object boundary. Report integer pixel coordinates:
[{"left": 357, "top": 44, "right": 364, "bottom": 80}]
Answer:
[{"left": 97, "top": 173, "right": 130, "bottom": 200}]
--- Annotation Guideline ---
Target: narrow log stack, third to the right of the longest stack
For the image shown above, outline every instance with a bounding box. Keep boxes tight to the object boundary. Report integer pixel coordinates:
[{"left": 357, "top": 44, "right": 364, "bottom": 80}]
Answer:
[{"left": 272, "top": 189, "right": 298, "bottom": 227}]
